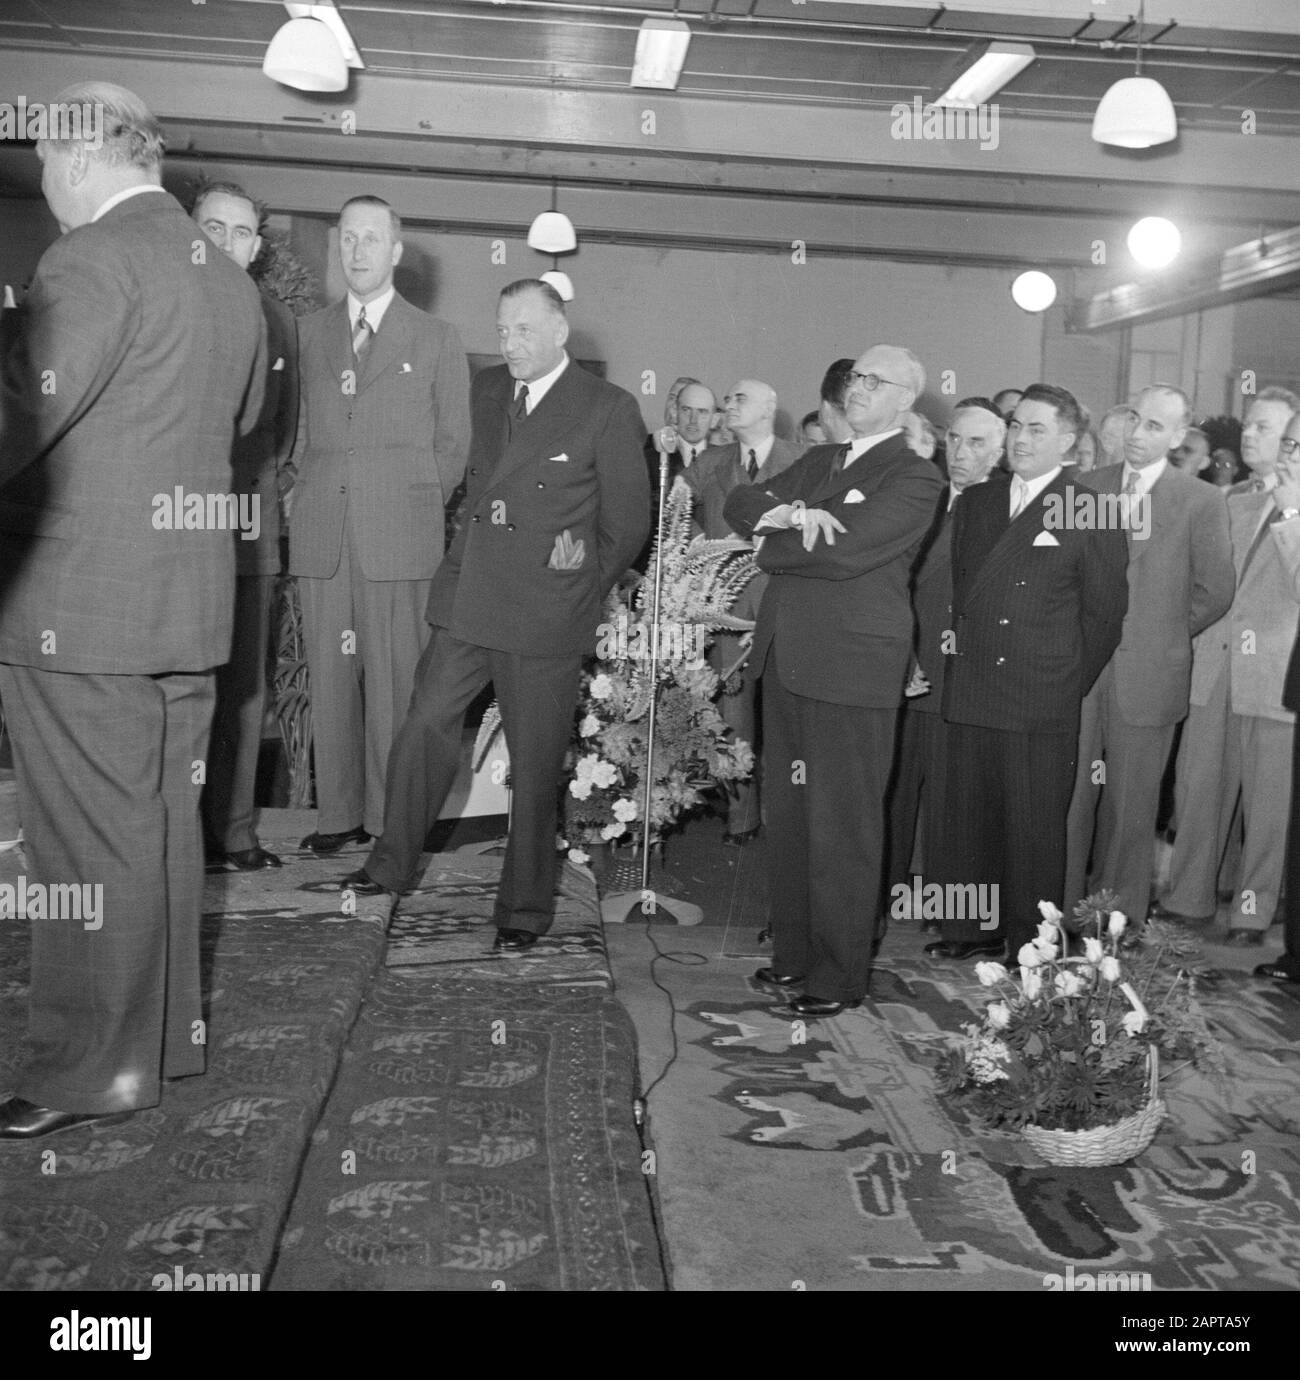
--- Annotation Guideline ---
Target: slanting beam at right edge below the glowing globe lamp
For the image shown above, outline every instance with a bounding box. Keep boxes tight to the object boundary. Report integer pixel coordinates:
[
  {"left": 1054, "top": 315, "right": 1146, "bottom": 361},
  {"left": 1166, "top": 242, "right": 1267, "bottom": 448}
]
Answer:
[{"left": 1065, "top": 225, "right": 1300, "bottom": 331}]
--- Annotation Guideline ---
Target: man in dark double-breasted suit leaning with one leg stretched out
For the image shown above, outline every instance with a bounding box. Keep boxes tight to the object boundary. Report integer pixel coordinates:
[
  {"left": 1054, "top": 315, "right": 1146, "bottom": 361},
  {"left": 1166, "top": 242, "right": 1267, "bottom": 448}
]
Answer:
[{"left": 342, "top": 279, "right": 649, "bottom": 949}]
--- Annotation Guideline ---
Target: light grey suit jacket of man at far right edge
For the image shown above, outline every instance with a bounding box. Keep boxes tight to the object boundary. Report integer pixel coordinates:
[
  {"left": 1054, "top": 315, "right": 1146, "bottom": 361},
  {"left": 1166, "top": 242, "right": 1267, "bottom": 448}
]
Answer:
[{"left": 1191, "top": 486, "right": 1300, "bottom": 723}]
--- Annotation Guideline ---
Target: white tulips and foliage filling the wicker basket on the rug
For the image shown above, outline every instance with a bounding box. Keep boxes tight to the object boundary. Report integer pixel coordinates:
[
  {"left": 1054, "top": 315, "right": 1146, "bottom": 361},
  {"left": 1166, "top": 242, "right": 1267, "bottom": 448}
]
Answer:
[{"left": 938, "top": 891, "right": 1223, "bottom": 1132}]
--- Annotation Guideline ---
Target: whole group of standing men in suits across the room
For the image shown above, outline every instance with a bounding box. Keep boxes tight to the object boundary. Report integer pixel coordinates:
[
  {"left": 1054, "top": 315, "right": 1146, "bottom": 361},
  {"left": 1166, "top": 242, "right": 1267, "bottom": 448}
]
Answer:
[{"left": 0, "top": 83, "right": 1300, "bottom": 1139}]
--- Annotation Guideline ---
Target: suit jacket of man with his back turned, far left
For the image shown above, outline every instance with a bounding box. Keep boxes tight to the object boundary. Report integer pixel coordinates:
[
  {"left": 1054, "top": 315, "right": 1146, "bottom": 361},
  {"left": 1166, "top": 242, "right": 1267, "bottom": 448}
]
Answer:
[{"left": 0, "top": 192, "right": 266, "bottom": 675}]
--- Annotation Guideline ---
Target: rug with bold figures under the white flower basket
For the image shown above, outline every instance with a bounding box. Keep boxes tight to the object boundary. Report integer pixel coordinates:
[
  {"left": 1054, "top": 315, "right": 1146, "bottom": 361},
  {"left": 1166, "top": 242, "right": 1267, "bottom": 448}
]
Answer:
[{"left": 629, "top": 945, "right": 1300, "bottom": 1293}]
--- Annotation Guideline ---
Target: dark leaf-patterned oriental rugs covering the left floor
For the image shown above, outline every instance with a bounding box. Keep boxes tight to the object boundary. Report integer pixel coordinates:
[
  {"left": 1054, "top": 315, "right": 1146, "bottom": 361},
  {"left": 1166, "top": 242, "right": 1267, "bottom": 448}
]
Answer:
[{"left": 0, "top": 828, "right": 664, "bottom": 1290}]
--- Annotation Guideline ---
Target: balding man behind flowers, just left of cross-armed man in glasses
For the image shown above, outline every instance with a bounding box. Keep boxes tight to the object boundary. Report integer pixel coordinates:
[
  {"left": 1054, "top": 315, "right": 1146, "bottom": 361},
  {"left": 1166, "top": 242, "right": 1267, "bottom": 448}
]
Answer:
[{"left": 678, "top": 378, "right": 795, "bottom": 847}]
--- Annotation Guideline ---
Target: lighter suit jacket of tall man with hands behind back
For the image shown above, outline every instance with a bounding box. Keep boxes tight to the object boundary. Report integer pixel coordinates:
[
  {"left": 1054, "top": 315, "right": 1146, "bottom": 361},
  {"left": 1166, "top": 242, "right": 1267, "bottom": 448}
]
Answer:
[{"left": 288, "top": 293, "right": 469, "bottom": 580}]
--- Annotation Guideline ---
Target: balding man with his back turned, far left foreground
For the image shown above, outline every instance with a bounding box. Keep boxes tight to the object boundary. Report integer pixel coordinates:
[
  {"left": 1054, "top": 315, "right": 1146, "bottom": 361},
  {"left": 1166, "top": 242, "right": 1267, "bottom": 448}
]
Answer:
[{"left": 0, "top": 83, "right": 266, "bottom": 1139}]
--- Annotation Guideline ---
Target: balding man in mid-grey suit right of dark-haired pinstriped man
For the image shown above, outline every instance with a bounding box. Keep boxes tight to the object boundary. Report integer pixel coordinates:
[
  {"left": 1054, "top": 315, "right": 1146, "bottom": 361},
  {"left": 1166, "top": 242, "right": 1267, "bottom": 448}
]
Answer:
[{"left": 1065, "top": 384, "right": 1237, "bottom": 920}]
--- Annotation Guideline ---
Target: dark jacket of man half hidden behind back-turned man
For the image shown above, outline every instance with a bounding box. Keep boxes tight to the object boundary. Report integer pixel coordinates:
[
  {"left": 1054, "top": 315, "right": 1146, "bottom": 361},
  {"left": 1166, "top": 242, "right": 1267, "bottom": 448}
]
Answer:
[{"left": 232, "top": 293, "right": 298, "bottom": 575}]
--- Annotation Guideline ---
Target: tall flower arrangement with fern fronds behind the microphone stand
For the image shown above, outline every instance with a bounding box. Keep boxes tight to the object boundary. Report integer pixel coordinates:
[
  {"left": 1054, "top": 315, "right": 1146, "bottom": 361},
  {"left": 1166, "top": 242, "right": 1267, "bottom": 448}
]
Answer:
[{"left": 475, "top": 480, "right": 756, "bottom": 863}]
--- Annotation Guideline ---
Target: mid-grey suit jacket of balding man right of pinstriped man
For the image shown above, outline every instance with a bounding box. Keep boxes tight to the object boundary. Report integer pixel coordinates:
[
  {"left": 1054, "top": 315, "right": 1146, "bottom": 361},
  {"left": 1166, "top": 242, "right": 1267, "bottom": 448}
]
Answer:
[{"left": 1079, "top": 465, "right": 1237, "bottom": 727}]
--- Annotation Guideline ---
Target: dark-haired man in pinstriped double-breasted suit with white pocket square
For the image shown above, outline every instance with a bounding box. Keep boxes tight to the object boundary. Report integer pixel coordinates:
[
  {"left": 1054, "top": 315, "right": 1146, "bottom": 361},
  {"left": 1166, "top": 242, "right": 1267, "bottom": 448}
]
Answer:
[{"left": 926, "top": 384, "right": 1129, "bottom": 962}]
